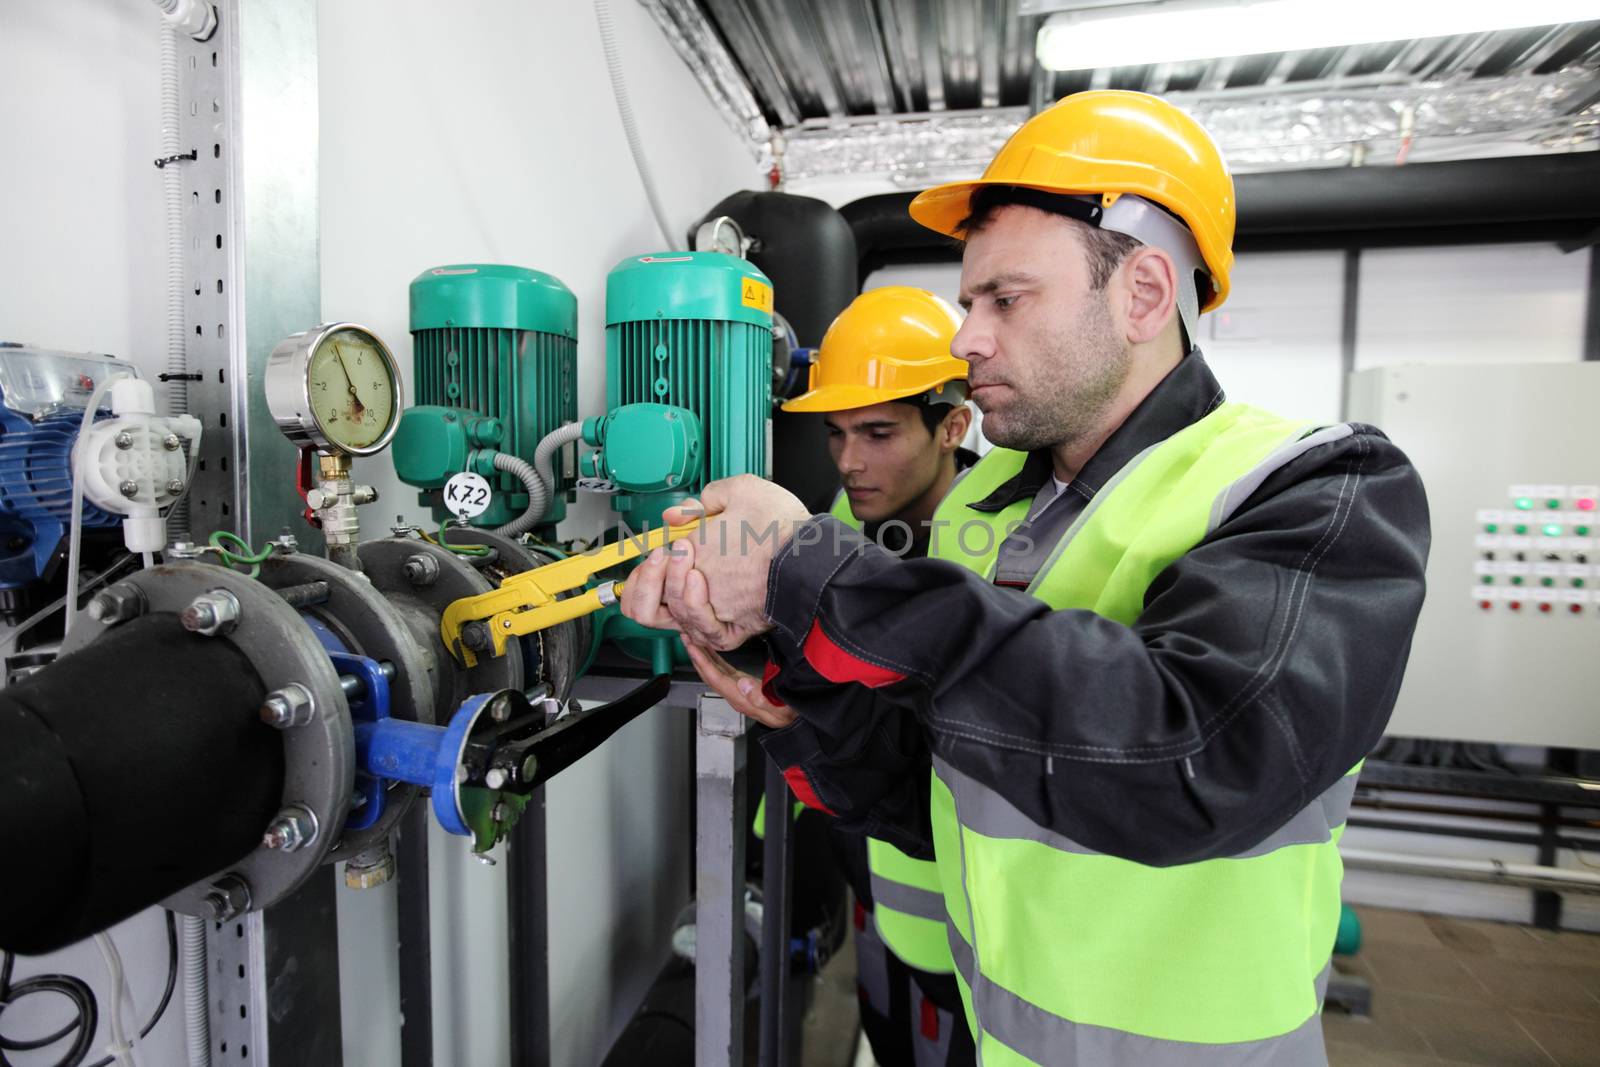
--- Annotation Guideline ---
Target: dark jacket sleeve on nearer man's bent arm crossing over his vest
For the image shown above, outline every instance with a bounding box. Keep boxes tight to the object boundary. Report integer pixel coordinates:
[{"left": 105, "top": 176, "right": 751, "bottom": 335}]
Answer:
[{"left": 770, "top": 434, "right": 1427, "bottom": 864}]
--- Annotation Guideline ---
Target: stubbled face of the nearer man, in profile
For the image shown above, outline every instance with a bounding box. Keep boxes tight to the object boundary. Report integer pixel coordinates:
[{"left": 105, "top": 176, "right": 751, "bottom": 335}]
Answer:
[{"left": 950, "top": 205, "right": 1131, "bottom": 451}]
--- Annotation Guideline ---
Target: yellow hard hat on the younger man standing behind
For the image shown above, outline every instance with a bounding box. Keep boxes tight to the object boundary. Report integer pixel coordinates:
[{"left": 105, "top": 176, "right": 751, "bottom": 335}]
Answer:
[{"left": 784, "top": 285, "right": 966, "bottom": 411}]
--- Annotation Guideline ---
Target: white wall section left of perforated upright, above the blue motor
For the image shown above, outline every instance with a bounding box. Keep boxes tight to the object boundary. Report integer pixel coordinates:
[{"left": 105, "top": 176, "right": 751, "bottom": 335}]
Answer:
[{"left": 0, "top": 0, "right": 166, "bottom": 363}]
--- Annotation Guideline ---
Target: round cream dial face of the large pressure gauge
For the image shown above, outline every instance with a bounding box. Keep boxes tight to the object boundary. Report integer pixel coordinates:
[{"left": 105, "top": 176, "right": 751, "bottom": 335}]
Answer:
[{"left": 306, "top": 328, "right": 395, "bottom": 453}]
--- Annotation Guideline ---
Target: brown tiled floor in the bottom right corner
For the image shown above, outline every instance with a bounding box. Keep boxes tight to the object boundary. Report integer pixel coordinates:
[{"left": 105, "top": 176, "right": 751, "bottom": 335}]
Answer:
[{"left": 1323, "top": 909, "right": 1600, "bottom": 1067}]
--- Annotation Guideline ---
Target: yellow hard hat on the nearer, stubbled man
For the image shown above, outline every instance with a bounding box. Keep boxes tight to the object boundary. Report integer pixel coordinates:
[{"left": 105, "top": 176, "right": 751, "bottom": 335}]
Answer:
[{"left": 910, "top": 90, "right": 1235, "bottom": 312}]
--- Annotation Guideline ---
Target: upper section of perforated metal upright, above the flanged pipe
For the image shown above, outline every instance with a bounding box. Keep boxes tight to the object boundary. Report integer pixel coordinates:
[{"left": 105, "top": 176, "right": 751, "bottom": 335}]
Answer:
[{"left": 178, "top": 0, "right": 322, "bottom": 552}]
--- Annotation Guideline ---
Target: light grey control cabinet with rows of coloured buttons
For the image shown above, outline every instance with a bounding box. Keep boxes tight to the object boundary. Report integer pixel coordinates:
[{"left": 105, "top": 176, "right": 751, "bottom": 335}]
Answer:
[{"left": 1347, "top": 367, "right": 1600, "bottom": 749}]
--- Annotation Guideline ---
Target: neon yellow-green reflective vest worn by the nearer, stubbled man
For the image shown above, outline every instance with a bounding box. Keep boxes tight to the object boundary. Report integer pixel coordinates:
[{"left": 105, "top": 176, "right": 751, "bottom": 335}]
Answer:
[{"left": 930, "top": 403, "right": 1360, "bottom": 1067}]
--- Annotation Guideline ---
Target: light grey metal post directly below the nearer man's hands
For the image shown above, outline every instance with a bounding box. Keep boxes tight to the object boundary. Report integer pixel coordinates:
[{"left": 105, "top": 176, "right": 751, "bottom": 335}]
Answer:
[{"left": 694, "top": 696, "right": 749, "bottom": 1067}]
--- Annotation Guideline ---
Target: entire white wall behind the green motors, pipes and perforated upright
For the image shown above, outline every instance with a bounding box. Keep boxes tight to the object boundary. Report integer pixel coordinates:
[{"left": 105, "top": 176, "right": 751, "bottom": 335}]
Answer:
[{"left": 0, "top": 0, "right": 762, "bottom": 1067}]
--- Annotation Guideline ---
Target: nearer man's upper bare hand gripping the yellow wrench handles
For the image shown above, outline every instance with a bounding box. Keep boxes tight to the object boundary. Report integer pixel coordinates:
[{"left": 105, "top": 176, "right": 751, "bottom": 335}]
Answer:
[{"left": 622, "top": 475, "right": 811, "bottom": 652}]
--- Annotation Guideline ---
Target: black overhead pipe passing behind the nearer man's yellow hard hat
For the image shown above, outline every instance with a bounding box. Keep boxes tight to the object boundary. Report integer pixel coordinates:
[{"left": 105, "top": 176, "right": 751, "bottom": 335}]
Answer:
[{"left": 840, "top": 152, "right": 1600, "bottom": 275}]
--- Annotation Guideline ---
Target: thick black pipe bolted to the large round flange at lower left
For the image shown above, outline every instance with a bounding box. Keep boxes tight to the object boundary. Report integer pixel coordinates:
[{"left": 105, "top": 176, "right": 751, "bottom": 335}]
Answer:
[{"left": 0, "top": 613, "right": 283, "bottom": 953}]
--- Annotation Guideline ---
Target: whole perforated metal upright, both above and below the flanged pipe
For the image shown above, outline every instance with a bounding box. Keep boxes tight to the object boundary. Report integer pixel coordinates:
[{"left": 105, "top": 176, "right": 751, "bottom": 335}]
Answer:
[{"left": 178, "top": 0, "right": 342, "bottom": 1065}]
